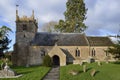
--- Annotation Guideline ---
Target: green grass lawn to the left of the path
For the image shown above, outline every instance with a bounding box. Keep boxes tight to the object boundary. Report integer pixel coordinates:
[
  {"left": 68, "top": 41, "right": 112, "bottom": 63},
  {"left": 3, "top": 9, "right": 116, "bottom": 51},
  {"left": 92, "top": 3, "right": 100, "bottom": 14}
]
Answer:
[{"left": 0, "top": 66, "right": 50, "bottom": 80}]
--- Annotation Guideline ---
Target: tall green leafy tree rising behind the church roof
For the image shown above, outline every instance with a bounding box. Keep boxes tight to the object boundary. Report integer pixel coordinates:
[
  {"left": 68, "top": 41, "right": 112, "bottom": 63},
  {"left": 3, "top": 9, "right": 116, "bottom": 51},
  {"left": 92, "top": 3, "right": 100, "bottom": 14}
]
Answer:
[{"left": 55, "top": 0, "right": 87, "bottom": 32}]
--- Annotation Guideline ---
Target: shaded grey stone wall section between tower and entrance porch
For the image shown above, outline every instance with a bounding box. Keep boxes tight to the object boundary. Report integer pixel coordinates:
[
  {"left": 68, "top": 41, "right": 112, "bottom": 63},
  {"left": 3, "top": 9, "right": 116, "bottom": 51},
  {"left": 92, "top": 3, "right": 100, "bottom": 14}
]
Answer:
[{"left": 28, "top": 46, "right": 51, "bottom": 65}]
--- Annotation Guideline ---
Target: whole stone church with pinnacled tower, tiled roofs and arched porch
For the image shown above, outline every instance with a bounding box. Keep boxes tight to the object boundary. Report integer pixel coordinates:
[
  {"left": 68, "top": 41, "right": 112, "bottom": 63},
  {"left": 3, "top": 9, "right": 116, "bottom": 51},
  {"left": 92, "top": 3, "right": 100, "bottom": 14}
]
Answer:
[{"left": 12, "top": 10, "right": 113, "bottom": 66}]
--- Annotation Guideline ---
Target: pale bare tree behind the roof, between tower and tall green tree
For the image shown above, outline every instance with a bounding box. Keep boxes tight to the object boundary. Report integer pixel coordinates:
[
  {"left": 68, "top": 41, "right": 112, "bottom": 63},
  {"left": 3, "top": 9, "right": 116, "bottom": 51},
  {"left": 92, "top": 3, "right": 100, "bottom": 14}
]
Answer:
[{"left": 42, "top": 21, "right": 57, "bottom": 32}]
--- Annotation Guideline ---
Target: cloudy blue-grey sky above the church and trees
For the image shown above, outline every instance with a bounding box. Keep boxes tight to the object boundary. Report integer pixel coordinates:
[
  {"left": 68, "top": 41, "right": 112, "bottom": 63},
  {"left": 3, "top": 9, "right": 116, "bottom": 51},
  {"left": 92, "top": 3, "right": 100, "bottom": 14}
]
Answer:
[{"left": 0, "top": 0, "right": 120, "bottom": 49}]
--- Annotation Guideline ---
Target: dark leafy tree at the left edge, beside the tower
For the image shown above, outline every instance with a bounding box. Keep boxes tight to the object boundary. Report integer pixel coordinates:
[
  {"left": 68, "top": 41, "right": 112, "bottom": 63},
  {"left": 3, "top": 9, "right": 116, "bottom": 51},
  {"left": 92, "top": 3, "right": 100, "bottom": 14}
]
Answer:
[{"left": 0, "top": 26, "right": 12, "bottom": 57}]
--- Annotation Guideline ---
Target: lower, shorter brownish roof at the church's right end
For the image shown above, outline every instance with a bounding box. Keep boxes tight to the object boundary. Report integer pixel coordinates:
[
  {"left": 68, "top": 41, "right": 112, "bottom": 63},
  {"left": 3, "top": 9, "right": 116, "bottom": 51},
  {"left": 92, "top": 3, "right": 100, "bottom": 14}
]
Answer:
[{"left": 87, "top": 36, "right": 113, "bottom": 46}]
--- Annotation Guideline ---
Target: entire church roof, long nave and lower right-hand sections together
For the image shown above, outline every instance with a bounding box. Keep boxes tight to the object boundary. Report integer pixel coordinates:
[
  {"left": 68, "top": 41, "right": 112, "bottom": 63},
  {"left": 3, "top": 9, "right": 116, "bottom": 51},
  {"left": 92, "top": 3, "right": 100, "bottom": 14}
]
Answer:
[{"left": 31, "top": 32, "right": 113, "bottom": 46}]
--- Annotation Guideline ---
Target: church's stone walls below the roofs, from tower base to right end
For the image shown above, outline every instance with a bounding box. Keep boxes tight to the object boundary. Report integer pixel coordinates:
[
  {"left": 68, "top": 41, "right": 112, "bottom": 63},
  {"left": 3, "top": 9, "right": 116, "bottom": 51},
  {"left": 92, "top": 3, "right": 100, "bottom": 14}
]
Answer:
[{"left": 13, "top": 43, "right": 113, "bottom": 66}]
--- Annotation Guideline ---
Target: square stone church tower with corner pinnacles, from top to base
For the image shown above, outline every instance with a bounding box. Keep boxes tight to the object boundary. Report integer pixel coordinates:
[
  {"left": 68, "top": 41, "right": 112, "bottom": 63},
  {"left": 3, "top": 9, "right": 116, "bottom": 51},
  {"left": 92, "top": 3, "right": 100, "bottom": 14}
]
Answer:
[{"left": 12, "top": 6, "right": 38, "bottom": 66}]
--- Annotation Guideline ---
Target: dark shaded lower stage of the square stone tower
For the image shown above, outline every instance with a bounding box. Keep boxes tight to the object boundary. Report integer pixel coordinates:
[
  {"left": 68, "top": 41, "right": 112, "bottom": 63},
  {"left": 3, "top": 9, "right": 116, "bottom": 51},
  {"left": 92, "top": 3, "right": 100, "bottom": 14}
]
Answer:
[{"left": 12, "top": 43, "right": 29, "bottom": 66}]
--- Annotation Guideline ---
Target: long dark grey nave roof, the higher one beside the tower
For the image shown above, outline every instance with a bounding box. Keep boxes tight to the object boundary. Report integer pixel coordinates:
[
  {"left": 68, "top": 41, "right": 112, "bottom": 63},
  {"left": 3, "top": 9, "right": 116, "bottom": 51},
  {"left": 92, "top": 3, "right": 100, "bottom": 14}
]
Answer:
[{"left": 31, "top": 32, "right": 88, "bottom": 46}]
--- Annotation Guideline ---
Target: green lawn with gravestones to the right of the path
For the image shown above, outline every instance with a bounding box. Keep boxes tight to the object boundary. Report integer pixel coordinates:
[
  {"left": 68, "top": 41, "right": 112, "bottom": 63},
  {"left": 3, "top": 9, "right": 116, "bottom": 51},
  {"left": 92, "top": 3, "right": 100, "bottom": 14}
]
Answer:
[{"left": 60, "top": 63, "right": 120, "bottom": 80}]
